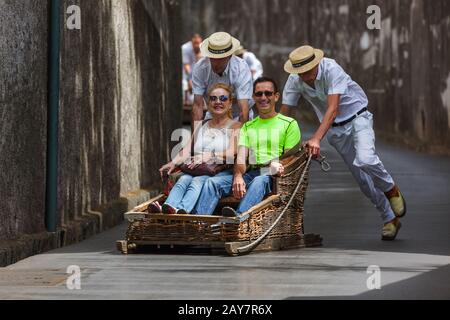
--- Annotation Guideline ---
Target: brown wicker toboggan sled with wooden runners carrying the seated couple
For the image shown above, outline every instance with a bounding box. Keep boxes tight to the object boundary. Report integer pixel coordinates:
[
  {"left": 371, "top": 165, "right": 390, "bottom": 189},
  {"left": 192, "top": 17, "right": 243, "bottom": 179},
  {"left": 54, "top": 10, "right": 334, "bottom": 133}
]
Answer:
[{"left": 117, "top": 151, "right": 322, "bottom": 255}]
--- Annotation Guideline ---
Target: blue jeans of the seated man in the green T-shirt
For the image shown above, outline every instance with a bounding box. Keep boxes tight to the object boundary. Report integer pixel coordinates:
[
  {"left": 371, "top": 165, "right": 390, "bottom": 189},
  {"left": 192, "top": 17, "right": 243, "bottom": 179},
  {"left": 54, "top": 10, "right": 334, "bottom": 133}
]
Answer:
[{"left": 194, "top": 170, "right": 272, "bottom": 215}]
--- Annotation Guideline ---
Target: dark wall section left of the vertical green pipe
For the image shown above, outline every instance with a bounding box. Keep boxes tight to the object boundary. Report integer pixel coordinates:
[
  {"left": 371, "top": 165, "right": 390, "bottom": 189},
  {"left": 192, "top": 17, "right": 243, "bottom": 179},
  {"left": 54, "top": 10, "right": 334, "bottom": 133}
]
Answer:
[{"left": 0, "top": 0, "right": 48, "bottom": 240}]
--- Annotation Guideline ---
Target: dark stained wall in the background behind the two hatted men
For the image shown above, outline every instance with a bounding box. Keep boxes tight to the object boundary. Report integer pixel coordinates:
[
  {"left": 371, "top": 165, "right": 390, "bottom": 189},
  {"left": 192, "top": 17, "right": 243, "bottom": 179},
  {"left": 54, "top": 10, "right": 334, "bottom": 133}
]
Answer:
[{"left": 183, "top": 0, "right": 450, "bottom": 153}]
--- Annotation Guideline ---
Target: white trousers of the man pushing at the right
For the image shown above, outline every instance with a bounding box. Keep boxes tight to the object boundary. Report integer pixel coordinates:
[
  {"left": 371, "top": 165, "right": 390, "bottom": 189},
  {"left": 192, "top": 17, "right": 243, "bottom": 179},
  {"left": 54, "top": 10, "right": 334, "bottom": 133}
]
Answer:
[{"left": 327, "top": 111, "right": 395, "bottom": 223}]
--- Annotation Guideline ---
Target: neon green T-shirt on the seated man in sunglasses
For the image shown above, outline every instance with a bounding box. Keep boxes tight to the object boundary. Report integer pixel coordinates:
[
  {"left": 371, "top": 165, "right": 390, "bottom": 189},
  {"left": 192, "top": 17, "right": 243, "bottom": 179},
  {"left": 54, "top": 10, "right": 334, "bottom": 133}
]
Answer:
[{"left": 239, "top": 114, "right": 301, "bottom": 165}]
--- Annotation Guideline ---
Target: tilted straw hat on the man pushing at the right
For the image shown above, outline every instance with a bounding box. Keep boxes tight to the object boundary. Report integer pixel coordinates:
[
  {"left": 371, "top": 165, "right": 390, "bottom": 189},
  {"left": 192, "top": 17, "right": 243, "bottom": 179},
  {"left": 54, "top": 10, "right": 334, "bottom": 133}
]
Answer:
[{"left": 284, "top": 46, "right": 324, "bottom": 74}]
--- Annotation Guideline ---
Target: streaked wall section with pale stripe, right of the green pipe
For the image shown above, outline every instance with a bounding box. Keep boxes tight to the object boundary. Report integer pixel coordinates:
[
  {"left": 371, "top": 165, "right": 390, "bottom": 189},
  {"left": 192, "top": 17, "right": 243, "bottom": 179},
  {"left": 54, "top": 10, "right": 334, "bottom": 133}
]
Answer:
[{"left": 58, "top": 0, "right": 181, "bottom": 229}]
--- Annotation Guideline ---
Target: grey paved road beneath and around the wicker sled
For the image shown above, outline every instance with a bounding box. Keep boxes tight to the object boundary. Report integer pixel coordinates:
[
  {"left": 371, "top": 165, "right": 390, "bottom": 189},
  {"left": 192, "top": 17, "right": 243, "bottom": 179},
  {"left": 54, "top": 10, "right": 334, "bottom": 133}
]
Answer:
[{"left": 0, "top": 131, "right": 450, "bottom": 299}]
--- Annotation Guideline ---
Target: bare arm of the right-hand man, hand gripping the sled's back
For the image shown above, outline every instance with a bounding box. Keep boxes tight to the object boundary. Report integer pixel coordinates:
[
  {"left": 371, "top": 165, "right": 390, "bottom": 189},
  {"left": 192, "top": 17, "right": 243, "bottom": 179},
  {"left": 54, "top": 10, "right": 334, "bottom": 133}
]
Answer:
[{"left": 305, "top": 94, "right": 341, "bottom": 156}]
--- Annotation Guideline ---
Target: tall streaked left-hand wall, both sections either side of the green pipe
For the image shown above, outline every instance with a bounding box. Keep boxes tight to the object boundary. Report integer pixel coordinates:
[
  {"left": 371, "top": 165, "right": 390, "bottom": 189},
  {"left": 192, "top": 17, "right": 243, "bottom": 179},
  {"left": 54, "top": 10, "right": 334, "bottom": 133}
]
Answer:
[{"left": 0, "top": 0, "right": 182, "bottom": 245}]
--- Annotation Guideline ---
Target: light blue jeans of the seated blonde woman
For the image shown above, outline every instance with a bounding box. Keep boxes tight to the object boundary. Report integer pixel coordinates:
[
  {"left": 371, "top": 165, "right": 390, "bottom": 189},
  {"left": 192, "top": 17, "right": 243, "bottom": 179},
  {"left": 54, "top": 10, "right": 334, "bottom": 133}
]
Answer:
[{"left": 165, "top": 174, "right": 209, "bottom": 213}]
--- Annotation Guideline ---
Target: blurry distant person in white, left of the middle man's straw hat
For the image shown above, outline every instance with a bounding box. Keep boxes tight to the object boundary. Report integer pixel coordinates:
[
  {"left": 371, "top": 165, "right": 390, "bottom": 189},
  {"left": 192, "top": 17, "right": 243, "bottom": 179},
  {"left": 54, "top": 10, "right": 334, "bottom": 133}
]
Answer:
[{"left": 181, "top": 34, "right": 203, "bottom": 105}]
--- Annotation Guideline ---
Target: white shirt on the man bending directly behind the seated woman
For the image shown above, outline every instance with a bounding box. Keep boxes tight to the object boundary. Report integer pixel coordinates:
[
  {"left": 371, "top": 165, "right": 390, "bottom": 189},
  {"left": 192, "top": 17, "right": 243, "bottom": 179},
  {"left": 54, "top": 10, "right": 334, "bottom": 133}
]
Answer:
[{"left": 192, "top": 56, "right": 253, "bottom": 119}]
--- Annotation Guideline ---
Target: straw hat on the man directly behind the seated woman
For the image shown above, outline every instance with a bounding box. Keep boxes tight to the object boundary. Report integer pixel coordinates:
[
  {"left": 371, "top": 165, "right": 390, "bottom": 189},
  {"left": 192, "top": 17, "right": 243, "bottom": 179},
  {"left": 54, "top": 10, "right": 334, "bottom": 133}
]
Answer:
[{"left": 200, "top": 32, "right": 241, "bottom": 59}]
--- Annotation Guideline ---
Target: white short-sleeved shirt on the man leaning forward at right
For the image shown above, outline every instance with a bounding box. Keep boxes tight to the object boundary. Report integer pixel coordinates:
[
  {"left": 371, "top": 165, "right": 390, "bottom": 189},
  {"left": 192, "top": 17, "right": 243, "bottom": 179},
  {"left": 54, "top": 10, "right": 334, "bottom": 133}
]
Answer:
[{"left": 283, "top": 58, "right": 368, "bottom": 122}]
